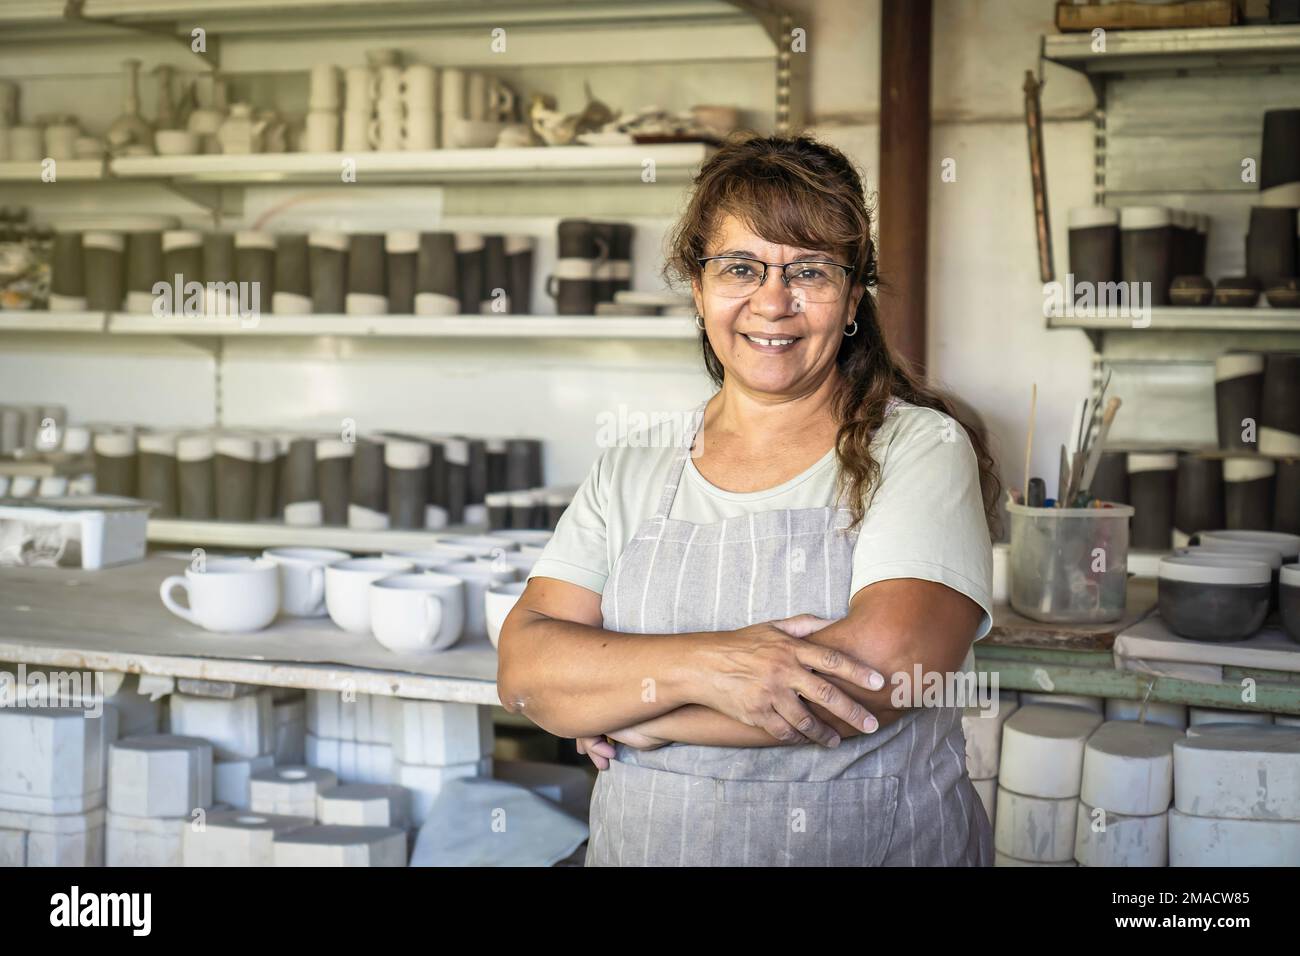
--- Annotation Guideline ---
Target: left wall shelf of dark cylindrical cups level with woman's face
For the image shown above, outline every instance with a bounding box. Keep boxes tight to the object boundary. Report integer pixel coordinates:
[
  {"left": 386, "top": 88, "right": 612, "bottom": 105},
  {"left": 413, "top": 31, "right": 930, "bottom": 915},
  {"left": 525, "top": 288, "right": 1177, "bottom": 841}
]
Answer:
[{"left": 0, "top": 209, "right": 693, "bottom": 337}]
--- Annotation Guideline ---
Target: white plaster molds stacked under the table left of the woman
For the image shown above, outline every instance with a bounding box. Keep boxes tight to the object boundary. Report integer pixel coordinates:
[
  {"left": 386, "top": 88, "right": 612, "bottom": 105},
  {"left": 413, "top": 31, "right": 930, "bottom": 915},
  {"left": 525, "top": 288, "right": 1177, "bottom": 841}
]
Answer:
[{"left": 0, "top": 681, "right": 592, "bottom": 866}]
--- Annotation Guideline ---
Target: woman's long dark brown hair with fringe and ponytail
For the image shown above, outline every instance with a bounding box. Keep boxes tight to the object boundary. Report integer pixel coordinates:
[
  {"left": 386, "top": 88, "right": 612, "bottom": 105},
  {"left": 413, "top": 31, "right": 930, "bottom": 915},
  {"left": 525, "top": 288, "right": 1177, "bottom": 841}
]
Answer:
[{"left": 667, "top": 134, "right": 1001, "bottom": 531}]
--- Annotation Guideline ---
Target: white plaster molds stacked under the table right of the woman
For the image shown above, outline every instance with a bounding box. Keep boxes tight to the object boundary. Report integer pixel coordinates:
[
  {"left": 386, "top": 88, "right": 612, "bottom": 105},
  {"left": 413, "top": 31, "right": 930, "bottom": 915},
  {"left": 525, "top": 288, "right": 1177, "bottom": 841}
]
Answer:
[{"left": 962, "top": 692, "right": 1300, "bottom": 866}]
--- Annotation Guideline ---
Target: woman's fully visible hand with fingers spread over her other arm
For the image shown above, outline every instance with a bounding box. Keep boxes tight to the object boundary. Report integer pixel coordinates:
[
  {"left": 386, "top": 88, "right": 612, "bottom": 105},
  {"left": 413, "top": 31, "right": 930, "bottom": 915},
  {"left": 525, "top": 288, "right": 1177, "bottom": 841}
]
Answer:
[{"left": 699, "top": 614, "right": 885, "bottom": 747}]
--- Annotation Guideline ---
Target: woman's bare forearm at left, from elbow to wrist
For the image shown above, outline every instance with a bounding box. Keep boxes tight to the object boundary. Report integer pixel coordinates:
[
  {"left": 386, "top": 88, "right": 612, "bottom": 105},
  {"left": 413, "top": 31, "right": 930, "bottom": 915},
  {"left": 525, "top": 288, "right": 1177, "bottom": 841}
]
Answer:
[{"left": 497, "top": 609, "right": 699, "bottom": 737}]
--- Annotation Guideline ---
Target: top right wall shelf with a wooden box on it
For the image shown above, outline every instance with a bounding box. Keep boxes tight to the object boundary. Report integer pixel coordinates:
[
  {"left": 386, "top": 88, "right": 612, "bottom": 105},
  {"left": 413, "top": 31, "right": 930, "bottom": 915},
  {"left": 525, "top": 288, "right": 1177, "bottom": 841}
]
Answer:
[{"left": 1043, "top": 25, "right": 1300, "bottom": 74}]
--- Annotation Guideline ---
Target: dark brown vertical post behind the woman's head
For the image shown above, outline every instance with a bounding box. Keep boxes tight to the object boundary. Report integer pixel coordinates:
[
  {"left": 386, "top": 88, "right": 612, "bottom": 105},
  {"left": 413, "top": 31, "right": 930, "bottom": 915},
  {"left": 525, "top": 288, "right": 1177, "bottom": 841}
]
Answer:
[{"left": 878, "top": 0, "right": 935, "bottom": 372}]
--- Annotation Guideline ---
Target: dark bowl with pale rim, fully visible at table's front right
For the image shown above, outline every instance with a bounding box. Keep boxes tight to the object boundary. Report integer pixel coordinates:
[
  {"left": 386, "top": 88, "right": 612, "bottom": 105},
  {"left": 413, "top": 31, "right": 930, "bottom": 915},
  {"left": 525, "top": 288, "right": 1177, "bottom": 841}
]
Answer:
[{"left": 1157, "top": 553, "right": 1273, "bottom": 644}]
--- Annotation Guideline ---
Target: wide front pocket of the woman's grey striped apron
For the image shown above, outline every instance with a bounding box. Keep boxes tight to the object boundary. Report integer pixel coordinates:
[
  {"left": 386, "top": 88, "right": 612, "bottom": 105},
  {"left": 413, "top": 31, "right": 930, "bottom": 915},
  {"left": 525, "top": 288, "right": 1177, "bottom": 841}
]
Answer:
[{"left": 712, "top": 777, "right": 898, "bottom": 866}]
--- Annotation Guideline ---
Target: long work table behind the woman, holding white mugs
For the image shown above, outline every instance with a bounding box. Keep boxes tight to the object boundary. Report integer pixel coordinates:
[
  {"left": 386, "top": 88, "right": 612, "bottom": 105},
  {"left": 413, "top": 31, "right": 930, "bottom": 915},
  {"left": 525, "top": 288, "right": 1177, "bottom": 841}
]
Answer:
[{"left": 0, "top": 554, "right": 1300, "bottom": 713}]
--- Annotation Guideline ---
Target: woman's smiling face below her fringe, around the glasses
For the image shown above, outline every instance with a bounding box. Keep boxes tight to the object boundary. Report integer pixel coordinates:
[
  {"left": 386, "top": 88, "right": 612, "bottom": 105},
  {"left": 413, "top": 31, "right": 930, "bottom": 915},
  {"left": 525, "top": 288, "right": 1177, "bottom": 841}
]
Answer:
[{"left": 693, "top": 215, "right": 865, "bottom": 395}]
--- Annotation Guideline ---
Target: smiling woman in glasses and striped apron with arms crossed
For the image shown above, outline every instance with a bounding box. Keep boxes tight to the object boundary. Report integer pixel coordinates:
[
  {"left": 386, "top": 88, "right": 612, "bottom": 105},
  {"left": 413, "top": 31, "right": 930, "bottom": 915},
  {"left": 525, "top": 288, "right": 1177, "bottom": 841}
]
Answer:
[{"left": 498, "top": 137, "right": 996, "bottom": 865}]
